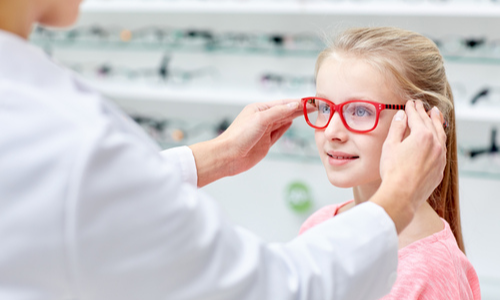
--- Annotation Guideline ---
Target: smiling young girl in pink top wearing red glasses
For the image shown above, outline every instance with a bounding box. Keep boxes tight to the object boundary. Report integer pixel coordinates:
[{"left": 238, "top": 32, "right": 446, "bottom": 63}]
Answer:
[{"left": 300, "top": 27, "right": 481, "bottom": 300}]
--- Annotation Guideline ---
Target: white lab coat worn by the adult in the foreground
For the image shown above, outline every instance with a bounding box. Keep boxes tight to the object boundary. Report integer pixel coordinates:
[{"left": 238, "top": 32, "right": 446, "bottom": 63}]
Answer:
[{"left": 0, "top": 31, "right": 397, "bottom": 300}]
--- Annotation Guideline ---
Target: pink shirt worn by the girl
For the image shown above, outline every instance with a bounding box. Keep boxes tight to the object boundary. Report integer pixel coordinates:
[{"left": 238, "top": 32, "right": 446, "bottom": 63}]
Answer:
[{"left": 299, "top": 200, "right": 481, "bottom": 300}]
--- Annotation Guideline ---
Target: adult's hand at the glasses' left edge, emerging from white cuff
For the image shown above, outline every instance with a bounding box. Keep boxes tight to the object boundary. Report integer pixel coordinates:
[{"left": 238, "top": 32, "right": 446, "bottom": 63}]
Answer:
[{"left": 190, "top": 100, "right": 302, "bottom": 187}]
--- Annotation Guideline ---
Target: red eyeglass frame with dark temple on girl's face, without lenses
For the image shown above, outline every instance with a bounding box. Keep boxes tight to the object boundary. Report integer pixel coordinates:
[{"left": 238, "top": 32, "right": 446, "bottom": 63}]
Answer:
[{"left": 301, "top": 97, "right": 406, "bottom": 133}]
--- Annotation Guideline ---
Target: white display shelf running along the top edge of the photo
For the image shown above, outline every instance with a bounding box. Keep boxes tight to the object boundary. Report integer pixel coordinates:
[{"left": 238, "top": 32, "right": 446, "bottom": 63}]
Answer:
[{"left": 82, "top": 0, "right": 500, "bottom": 18}]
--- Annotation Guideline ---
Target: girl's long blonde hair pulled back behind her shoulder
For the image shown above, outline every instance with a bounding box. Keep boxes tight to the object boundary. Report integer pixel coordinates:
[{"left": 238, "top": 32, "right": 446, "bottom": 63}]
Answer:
[{"left": 316, "top": 27, "right": 465, "bottom": 253}]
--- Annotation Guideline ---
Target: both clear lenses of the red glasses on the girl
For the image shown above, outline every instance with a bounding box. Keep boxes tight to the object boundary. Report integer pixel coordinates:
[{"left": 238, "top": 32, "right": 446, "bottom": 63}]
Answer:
[{"left": 307, "top": 99, "right": 377, "bottom": 131}]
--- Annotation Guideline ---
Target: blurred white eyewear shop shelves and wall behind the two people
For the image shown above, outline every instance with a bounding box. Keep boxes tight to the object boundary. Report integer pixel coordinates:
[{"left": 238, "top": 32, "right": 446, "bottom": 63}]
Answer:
[{"left": 31, "top": 0, "right": 500, "bottom": 300}]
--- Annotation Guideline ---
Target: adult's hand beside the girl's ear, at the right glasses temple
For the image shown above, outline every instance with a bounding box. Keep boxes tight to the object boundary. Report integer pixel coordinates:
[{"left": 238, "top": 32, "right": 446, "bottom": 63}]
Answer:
[{"left": 371, "top": 101, "right": 446, "bottom": 233}]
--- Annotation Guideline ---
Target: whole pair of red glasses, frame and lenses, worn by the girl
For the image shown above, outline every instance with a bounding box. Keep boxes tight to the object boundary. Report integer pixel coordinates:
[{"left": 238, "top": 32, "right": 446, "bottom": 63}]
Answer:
[{"left": 301, "top": 97, "right": 448, "bottom": 133}]
